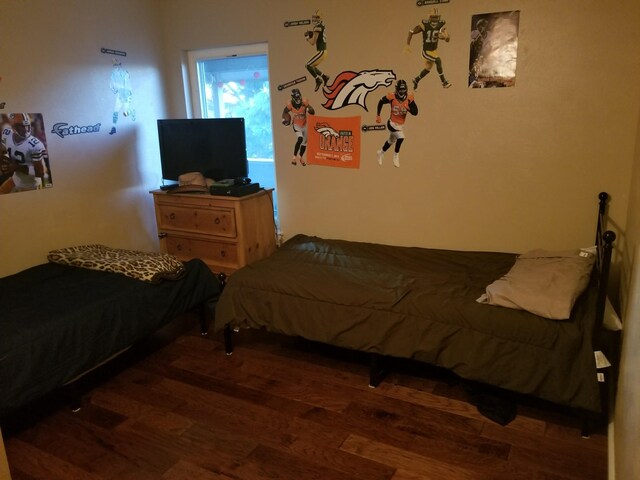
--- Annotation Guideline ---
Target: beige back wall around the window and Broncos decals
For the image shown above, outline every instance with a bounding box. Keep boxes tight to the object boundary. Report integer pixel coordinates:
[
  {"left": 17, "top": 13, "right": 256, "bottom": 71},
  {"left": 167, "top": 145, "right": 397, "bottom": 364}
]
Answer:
[{"left": 156, "top": 0, "right": 640, "bottom": 255}]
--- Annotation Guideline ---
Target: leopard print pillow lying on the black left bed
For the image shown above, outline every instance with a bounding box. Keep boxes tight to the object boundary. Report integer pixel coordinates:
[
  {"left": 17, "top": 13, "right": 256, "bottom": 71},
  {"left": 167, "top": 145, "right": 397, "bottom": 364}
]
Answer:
[{"left": 47, "top": 245, "right": 186, "bottom": 283}]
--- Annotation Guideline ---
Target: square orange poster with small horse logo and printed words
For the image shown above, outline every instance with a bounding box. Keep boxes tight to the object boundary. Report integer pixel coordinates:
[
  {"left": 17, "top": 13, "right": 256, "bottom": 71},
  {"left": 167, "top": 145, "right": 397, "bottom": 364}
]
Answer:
[{"left": 307, "top": 115, "right": 360, "bottom": 168}]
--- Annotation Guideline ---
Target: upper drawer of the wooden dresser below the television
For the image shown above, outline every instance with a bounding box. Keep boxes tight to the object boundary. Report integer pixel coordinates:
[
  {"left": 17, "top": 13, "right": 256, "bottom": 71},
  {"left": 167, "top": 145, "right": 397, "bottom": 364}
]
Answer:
[{"left": 158, "top": 204, "right": 237, "bottom": 238}]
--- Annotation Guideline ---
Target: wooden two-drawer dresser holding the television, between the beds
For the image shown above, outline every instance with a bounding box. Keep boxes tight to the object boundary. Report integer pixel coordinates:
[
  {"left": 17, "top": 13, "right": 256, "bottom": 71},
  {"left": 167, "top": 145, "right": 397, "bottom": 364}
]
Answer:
[{"left": 151, "top": 190, "right": 276, "bottom": 274}]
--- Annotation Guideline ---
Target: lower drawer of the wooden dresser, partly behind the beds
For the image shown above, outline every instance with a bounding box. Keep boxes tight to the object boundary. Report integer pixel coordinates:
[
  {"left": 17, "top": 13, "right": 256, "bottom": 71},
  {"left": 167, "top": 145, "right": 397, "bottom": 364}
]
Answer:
[{"left": 163, "top": 234, "right": 238, "bottom": 267}]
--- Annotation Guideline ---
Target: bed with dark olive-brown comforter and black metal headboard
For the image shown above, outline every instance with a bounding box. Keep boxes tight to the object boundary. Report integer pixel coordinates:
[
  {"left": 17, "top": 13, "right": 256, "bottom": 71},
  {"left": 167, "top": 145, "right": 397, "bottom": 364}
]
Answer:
[{"left": 215, "top": 193, "right": 615, "bottom": 428}]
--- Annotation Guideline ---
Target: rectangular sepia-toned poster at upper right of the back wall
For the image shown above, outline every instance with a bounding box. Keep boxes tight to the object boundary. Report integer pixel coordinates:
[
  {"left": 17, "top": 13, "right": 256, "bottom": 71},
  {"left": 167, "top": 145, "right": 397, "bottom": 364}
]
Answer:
[{"left": 469, "top": 10, "right": 520, "bottom": 88}]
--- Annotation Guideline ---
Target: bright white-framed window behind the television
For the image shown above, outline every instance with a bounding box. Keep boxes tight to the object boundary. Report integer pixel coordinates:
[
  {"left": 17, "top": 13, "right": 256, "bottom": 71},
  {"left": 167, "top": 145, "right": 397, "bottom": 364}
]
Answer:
[{"left": 188, "top": 44, "right": 278, "bottom": 222}]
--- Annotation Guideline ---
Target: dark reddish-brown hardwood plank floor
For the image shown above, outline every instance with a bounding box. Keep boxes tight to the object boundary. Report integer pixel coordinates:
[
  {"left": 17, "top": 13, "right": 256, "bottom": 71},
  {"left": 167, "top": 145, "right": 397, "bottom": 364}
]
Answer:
[{"left": 2, "top": 316, "right": 607, "bottom": 480}]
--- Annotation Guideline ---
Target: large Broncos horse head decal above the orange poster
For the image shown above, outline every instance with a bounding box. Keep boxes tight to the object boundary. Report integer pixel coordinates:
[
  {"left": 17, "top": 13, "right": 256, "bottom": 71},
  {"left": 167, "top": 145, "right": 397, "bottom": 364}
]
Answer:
[{"left": 322, "top": 70, "right": 396, "bottom": 111}]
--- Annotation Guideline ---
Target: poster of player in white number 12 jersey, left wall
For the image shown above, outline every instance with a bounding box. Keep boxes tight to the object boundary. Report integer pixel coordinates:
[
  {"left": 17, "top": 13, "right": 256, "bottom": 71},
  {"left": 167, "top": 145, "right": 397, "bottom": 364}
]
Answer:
[{"left": 0, "top": 113, "right": 53, "bottom": 194}]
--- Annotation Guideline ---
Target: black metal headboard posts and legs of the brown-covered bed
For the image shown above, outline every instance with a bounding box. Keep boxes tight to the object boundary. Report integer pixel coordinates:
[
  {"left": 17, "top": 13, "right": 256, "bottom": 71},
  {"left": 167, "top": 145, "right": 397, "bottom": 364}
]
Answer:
[{"left": 219, "top": 192, "right": 616, "bottom": 437}]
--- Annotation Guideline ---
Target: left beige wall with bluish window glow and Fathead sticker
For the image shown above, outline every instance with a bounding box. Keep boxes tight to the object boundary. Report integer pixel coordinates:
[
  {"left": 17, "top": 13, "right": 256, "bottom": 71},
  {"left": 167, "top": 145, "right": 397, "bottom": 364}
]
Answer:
[{"left": 0, "top": 0, "right": 164, "bottom": 275}]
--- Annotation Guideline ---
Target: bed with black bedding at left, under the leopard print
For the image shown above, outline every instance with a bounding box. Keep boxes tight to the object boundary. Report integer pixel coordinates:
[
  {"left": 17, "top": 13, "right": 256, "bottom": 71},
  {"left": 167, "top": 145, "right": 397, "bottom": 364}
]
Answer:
[{"left": 0, "top": 249, "right": 220, "bottom": 418}]
